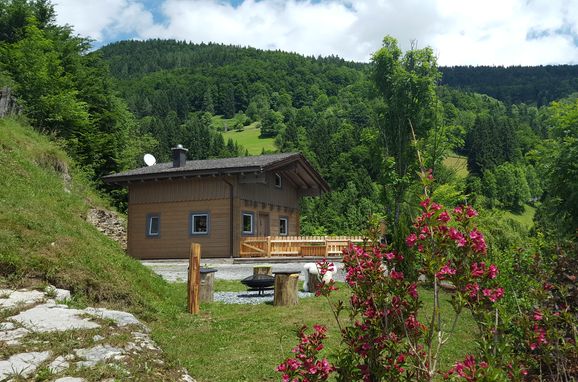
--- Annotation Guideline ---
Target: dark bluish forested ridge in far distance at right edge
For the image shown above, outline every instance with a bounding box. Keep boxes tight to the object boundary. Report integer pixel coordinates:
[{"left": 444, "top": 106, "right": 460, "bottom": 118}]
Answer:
[{"left": 440, "top": 65, "right": 578, "bottom": 106}]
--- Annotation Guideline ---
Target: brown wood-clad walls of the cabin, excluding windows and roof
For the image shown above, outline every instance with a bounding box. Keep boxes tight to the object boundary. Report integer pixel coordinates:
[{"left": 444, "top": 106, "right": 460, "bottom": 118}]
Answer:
[{"left": 128, "top": 173, "right": 299, "bottom": 259}]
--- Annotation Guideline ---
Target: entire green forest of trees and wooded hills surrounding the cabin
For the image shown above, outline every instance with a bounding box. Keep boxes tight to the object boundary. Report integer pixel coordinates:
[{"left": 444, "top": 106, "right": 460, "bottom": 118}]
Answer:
[{"left": 0, "top": 0, "right": 578, "bottom": 245}]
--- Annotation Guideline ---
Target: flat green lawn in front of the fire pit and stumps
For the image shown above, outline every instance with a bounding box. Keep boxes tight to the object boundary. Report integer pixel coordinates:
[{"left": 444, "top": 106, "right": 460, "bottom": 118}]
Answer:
[{"left": 152, "top": 280, "right": 477, "bottom": 382}]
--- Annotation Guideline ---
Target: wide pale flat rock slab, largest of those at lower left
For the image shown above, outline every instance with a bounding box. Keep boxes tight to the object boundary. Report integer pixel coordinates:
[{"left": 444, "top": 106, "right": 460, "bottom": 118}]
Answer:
[{"left": 10, "top": 304, "right": 100, "bottom": 332}]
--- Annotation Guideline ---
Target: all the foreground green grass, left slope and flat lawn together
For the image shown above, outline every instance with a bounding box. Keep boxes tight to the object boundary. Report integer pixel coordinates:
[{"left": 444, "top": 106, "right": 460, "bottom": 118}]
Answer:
[{"left": 0, "top": 119, "right": 475, "bottom": 382}]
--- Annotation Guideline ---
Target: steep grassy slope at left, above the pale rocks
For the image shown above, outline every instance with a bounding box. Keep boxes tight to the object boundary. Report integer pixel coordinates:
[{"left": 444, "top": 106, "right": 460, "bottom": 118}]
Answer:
[{"left": 0, "top": 119, "right": 168, "bottom": 319}]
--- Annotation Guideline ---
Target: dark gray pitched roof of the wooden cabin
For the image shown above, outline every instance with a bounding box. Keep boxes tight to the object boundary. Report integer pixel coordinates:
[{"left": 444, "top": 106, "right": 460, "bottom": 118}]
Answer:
[{"left": 102, "top": 153, "right": 329, "bottom": 190}]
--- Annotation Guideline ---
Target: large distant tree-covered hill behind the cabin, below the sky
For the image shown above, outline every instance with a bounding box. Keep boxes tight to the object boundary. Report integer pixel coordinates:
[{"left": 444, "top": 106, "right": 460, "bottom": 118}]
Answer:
[{"left": 99, "top": 40, "right": 362, "bottom": 120}]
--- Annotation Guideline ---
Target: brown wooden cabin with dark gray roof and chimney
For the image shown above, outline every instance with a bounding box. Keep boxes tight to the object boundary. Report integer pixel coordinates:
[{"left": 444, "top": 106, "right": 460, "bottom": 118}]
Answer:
[{"left": 103, "top": 145, "right": 329, "bottom": 259}]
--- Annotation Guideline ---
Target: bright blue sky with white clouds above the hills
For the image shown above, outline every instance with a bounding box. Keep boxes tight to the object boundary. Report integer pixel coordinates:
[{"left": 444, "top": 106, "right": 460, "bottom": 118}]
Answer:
[{"left": 53, "top": 0, "right": 578, "bottom": 66}]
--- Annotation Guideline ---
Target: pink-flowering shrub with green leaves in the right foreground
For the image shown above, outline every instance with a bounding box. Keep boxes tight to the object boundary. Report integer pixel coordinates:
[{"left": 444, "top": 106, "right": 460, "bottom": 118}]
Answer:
[{"left": 278, "top": 176, "right": 578, "bottom": 382}]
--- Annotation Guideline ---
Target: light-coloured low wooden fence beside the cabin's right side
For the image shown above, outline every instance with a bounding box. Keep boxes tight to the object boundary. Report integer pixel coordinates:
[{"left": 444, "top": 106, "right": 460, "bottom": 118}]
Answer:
[{"left": 240, "top": 236, "right": 368, "bottom": 257}]
